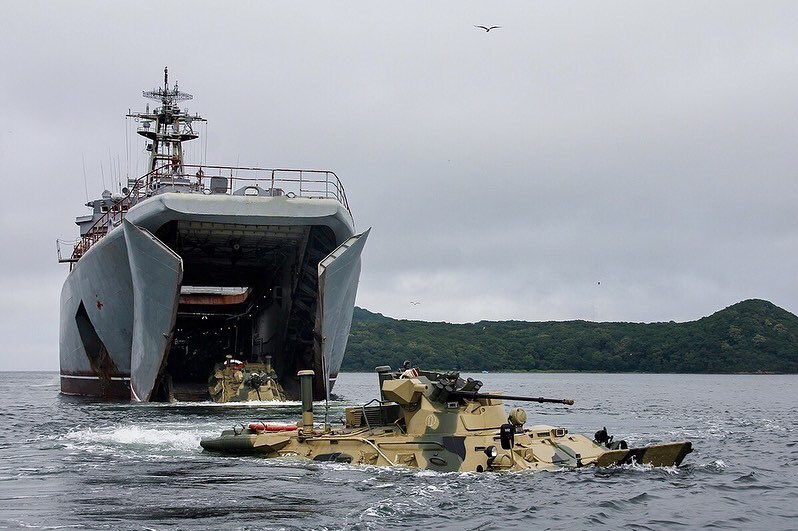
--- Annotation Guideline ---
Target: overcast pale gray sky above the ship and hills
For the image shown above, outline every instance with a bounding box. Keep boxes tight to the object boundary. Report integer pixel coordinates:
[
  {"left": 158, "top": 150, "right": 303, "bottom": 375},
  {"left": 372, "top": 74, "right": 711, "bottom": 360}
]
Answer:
[{"left": 0, "top": 0, "right": 798, "bottom": 369}]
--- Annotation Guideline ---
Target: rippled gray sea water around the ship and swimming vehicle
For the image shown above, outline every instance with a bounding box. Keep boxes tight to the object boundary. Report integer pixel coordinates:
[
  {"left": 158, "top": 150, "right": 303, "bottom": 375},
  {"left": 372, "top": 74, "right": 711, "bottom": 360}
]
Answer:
[{"left": 0, "top": 372, "right": 798, "bottom": 529}]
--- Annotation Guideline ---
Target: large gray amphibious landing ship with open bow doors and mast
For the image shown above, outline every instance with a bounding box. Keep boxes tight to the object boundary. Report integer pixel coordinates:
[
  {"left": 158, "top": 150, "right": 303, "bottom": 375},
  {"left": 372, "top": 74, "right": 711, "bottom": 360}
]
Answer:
[{"left": 58, "top": 69, "right": 368, "bottom": 401}]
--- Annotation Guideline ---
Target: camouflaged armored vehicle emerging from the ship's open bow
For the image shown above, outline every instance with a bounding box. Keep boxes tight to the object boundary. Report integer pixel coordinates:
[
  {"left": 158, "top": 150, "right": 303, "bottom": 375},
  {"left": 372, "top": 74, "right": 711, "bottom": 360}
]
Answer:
[{"left": 208, "top": 355, "right": 286, "bottom": 402}]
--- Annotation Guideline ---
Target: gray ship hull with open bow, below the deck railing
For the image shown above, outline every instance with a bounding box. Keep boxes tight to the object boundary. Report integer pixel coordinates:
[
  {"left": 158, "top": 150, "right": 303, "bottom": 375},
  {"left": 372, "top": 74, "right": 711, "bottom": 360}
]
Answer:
[{"left": 60, "top": 193, "right": 367, "bottom": 401}]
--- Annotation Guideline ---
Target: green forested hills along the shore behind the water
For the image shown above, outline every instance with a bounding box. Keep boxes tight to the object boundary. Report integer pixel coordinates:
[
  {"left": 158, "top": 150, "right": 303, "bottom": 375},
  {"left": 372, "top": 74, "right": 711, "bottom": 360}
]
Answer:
[{"left": 342, "top": 299, "right": 798, "bottom": 373}]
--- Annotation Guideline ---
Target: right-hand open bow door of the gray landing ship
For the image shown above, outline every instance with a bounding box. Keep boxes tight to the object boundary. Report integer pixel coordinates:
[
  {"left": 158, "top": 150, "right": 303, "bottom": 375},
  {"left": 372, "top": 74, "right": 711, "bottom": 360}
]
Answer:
[{"left": 316, "top": 229, "right": 371, "bottom": 401}]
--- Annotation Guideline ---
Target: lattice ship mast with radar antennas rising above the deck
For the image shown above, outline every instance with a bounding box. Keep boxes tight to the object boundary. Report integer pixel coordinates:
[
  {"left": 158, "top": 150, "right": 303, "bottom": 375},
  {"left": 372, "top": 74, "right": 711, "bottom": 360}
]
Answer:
[{"left": 127, "top": 67, "right": 206, "bottom": 188}]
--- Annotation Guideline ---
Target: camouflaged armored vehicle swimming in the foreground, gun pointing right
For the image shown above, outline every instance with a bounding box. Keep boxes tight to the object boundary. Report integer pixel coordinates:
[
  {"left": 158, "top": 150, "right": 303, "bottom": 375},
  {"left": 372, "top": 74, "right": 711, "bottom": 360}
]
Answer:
[{"left": 200, "top": 367, "right": 692, "bottom": 472}]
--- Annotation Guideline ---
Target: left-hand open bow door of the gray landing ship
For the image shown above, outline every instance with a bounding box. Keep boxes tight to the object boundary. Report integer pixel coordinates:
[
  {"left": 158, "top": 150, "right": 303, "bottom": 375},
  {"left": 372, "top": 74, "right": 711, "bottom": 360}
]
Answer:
[{"left": 122, "top": 220, "right": 183, "bottom": 402}]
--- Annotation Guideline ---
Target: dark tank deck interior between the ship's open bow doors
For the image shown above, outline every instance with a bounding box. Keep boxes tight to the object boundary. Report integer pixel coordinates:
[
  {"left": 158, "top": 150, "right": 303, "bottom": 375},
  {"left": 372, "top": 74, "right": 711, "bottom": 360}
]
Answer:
[{"left": 152, "top": 221, "right": 335, "bottom": 400}]
